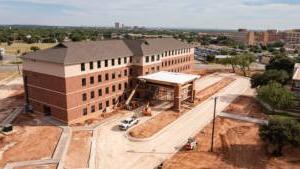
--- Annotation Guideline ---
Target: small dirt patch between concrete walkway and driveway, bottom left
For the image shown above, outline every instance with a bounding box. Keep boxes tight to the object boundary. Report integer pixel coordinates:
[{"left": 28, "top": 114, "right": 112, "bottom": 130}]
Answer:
[{"left": 65, "top": 131, "right": 92, "bottom": 169}]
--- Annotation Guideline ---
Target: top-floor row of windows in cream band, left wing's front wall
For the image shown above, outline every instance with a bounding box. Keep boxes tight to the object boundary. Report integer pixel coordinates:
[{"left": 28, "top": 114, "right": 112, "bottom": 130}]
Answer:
[{"left": 81, "top": 56, "right": 132, "bottom": 71}]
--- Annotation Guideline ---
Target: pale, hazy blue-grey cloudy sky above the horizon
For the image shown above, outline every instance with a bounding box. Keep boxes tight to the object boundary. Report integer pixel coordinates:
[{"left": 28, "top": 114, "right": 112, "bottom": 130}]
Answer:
[{"left": 0, "top": 0, "right": 300, "bottom": 29}]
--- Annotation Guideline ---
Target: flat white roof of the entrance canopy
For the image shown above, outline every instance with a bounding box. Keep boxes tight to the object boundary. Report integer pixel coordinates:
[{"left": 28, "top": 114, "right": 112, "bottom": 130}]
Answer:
[{"left": 138, "top": 71, "right": 200, "bottom": 85}]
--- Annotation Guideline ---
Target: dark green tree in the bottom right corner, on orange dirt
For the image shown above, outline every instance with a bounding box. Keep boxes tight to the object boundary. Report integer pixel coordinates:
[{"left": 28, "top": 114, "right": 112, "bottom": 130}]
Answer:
[{"left": 259, "top": 118, "right": 300, "bottom": 156}]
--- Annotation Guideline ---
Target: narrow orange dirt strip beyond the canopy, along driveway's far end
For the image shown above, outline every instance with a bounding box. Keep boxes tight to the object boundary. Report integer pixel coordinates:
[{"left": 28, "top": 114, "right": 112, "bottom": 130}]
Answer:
[{"left": 195, "top": 77, "right": 235, "bottom": 104}]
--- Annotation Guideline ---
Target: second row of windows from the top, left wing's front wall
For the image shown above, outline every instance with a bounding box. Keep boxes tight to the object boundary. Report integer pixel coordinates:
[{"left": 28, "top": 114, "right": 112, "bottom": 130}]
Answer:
[{"left": 81, "top": 68, "right": 133, "bottom": 86}]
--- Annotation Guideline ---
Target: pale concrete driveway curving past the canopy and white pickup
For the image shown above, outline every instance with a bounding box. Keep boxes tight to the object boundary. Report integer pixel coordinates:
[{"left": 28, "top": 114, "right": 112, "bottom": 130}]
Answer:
[{"left": 91, "top": 75, "right": 250, "bottom": 169}]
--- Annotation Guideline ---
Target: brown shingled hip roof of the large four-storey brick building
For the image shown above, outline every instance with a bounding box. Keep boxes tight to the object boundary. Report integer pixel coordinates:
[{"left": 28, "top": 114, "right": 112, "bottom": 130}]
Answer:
[{"left": 23, "top": 38, "right": 192, "bottom": 65}]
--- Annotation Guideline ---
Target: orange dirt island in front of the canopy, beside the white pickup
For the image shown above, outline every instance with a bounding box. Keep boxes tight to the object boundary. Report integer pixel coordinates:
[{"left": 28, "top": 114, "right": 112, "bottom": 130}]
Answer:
[{"left": 129, "top": 110, "right": 182, "bottom": 138}]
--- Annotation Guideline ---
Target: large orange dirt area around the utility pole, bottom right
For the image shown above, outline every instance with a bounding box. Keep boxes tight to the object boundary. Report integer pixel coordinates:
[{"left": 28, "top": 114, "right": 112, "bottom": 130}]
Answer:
[{"left": 164, "top": 118, "right": 300, "bottom": 169}]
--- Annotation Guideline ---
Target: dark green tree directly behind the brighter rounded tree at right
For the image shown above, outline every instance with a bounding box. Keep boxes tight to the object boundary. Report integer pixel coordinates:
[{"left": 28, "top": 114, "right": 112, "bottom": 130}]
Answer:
[{"left": 251, "top": 69, "right": 290, "bottom": 88}]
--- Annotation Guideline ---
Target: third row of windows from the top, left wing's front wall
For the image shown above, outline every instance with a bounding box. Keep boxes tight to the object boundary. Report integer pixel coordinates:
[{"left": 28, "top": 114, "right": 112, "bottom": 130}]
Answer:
[{"left": 82, "top": 81, "right": 132, "bottom": 101}]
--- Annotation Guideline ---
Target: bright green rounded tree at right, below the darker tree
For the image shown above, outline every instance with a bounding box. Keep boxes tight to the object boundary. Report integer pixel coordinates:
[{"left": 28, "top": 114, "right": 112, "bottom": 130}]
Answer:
[{"left": 257, "top": 82, "right": 295, "bottom": 109}]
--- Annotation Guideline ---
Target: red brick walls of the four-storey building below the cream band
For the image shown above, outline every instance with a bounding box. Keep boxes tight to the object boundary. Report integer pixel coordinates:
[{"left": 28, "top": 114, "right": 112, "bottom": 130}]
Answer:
[{"left": 23, "top": 52, "right": 194, "bottom": 123}]
